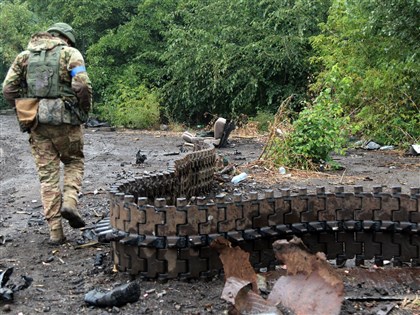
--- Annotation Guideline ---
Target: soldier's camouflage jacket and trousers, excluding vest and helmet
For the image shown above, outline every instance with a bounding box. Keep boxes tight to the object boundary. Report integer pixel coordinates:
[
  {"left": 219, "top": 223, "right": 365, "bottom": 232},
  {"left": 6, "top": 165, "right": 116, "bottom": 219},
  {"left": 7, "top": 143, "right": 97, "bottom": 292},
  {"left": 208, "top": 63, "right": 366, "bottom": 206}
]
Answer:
[{"left": 3, "top": 33, "right": 92, "bottom": 240}]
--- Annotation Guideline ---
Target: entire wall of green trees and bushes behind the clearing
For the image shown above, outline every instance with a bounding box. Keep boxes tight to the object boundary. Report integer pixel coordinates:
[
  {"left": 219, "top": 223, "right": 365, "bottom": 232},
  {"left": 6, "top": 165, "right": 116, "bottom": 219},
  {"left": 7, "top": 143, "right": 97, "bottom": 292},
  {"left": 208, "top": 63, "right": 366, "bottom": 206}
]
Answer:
[{"left": 0, "top": 0, "right": 420, "bottom": 168}]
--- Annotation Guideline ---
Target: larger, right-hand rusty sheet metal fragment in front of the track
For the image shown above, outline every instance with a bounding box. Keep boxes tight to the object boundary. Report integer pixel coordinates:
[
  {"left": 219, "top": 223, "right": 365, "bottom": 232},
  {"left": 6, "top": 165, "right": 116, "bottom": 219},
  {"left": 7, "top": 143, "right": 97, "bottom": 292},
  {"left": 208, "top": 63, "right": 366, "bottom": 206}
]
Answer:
[{"left": 267, "top": 237, "right": 344, "bottom": 315}]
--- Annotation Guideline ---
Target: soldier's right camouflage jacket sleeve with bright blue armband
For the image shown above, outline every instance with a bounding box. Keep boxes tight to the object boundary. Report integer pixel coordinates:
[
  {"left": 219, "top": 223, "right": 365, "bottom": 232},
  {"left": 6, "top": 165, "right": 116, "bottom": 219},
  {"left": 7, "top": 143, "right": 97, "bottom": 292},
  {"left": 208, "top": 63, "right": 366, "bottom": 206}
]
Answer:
[{"left": 67, "top": 48, "right": 92, "bottom": 112}]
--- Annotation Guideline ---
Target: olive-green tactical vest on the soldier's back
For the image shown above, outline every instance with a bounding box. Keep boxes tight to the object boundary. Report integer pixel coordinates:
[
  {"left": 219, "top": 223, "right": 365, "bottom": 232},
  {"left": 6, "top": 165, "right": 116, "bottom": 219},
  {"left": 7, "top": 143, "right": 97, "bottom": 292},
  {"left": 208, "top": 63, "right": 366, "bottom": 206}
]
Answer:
[{"left": 26, "top": 45, "right": 75, "bottom": 98}]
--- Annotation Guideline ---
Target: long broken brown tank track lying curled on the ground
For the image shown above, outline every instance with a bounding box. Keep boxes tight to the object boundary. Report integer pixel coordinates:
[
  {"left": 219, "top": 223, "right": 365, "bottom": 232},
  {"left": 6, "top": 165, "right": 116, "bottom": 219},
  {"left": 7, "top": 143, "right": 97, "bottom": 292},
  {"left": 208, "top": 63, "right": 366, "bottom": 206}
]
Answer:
[{"left": 102, "top": 144, "right": 420, "bottom": 279}]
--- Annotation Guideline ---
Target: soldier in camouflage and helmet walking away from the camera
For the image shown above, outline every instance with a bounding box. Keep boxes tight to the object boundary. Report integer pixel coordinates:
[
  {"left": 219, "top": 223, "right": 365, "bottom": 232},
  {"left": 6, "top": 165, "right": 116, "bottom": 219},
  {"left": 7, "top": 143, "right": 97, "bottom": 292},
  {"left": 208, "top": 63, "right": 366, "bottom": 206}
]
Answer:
[{"left": 3, "top": 23, "right": 92, "bottom": 245}]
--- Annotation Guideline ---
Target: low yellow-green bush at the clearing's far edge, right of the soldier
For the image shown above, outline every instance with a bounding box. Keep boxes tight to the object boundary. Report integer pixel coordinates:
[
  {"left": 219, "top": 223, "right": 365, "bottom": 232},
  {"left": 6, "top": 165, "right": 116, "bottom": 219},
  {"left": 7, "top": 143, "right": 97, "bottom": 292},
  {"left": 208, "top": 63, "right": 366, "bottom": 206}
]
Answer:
[{"left": 98, "top": 82, "right": 160, "bottom": 129}]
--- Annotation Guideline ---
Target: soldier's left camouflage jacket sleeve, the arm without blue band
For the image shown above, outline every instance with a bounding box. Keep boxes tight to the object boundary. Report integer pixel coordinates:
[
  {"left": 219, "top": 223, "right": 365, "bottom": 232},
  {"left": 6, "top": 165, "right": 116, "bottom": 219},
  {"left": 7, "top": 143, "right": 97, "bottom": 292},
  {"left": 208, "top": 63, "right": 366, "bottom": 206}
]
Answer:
[{"left": 3, "top": 51, "right": 29, "bottom": 107}]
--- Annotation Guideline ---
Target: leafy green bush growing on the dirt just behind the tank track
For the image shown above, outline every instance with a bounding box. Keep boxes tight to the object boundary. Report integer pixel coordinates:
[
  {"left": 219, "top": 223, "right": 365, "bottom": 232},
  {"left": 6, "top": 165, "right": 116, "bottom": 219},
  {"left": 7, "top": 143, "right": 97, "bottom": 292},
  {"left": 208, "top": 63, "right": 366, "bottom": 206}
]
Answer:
[{"left": 267, "top": 69, "right": 350, "bottom": 169}]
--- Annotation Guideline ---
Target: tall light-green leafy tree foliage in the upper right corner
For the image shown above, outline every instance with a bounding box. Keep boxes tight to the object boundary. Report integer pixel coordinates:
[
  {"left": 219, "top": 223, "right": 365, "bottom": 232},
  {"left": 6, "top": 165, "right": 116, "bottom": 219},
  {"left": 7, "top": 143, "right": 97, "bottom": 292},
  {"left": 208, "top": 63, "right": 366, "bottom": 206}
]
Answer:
[{"left": 312, "top": 0, "right": 420, "bottom": 144}]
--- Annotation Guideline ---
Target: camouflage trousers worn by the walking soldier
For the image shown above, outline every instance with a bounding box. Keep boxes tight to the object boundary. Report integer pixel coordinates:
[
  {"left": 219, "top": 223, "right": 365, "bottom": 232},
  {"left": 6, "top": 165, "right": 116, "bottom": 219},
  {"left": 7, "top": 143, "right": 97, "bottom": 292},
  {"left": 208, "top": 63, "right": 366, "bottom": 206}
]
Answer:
[{"left": 29, "top": 124, "right": 84, "bottom": 229}]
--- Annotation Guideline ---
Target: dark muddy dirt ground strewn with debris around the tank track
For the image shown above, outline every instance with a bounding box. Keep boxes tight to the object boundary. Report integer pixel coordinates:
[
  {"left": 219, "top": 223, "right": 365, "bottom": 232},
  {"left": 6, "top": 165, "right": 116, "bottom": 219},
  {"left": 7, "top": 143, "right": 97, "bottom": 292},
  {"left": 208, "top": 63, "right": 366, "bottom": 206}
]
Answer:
[{"left": 0, "top": 115, "right": 420, "bottom": 315}]
